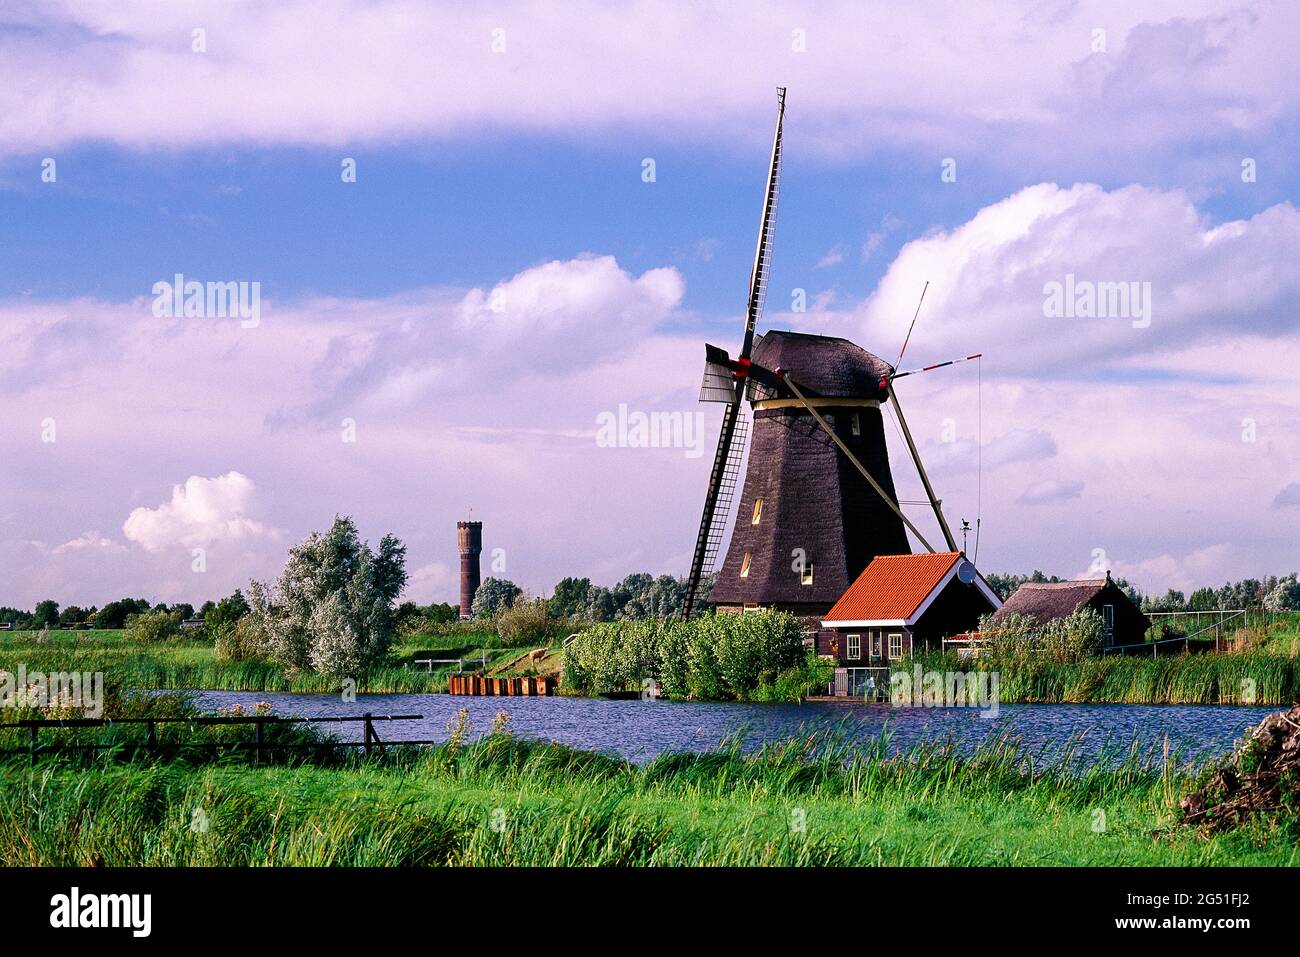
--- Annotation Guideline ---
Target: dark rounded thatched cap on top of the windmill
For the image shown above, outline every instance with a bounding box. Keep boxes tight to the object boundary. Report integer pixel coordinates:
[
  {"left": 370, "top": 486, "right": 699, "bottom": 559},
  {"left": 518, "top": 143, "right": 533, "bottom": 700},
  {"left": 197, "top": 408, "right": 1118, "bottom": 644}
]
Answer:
[{"left": 753, "top": 329, "right": 893, "bottom": 399}]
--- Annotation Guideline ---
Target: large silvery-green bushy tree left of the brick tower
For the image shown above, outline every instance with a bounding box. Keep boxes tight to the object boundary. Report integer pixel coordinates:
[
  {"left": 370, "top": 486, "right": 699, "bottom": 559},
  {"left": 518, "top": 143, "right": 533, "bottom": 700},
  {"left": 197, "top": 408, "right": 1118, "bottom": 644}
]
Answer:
[{"left": 248, "top": 518, "right": 407, "bottom": 676}]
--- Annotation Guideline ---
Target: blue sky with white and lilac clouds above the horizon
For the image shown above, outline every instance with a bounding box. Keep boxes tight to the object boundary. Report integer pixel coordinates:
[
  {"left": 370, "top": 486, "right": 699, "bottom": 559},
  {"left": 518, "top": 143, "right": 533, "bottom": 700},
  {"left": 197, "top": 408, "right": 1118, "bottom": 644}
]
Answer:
[{"left": 0, "top": 0, "right": 1300, "bottom": 607}]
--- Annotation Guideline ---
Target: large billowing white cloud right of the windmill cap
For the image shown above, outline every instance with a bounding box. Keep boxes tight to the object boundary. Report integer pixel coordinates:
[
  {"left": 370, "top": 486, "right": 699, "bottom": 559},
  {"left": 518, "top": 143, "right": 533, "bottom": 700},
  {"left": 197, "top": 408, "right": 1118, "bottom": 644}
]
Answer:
[{"left": 859, "top": 183, "right": 1300, "bottom": 378}]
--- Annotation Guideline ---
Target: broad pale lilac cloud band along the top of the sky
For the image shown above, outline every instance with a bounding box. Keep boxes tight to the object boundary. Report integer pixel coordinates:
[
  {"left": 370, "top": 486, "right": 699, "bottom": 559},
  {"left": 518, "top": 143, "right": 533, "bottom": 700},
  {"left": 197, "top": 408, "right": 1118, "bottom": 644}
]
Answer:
[{"left": 0, "top": 0, "right": 1300, "bottom": 174}]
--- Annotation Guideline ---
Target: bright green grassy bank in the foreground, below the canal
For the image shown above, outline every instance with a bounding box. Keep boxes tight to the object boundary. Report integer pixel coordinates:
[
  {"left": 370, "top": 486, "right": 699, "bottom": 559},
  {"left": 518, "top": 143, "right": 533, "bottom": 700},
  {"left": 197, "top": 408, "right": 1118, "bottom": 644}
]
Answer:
[{"left": 0, "top": 733, "right": 1300, "bottom": 866}]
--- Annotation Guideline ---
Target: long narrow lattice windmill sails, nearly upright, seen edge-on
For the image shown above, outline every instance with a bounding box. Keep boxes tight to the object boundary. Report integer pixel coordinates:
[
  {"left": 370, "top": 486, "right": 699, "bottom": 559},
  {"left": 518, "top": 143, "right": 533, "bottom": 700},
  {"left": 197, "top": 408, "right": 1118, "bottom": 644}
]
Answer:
[{"left": 684, "top": 87, "right": 785, "bottom": 618}]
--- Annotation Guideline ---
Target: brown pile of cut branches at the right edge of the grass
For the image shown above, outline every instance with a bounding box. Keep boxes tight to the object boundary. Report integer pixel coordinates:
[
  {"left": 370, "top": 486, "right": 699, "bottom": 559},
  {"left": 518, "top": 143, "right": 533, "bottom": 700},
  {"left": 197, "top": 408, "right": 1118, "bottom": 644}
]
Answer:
[{"left": 1179, "top": 705, "right": 1300, "bottom": 833}]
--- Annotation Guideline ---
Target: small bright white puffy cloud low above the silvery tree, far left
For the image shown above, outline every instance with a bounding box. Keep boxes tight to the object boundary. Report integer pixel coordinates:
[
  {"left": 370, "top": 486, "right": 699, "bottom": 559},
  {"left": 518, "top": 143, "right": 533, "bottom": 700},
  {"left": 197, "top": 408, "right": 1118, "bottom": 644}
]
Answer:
[{"left": 122, "top": 472, "right": 276, "bottom": 551}]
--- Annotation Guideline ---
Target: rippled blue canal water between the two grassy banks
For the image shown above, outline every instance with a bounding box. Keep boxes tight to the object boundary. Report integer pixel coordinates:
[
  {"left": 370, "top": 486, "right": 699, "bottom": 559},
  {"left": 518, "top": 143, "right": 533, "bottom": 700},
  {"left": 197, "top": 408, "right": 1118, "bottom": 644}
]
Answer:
[{"left": 188, "top": 692, "right": 1277, "bottom": 762}]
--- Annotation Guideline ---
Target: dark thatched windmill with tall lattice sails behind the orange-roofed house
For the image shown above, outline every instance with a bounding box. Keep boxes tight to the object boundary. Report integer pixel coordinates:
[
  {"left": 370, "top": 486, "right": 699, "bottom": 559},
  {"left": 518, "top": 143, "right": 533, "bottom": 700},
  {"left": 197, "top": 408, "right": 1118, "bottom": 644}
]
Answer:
[{"left": 685, "top": 88, "right": 978, "bottom": 618}]
